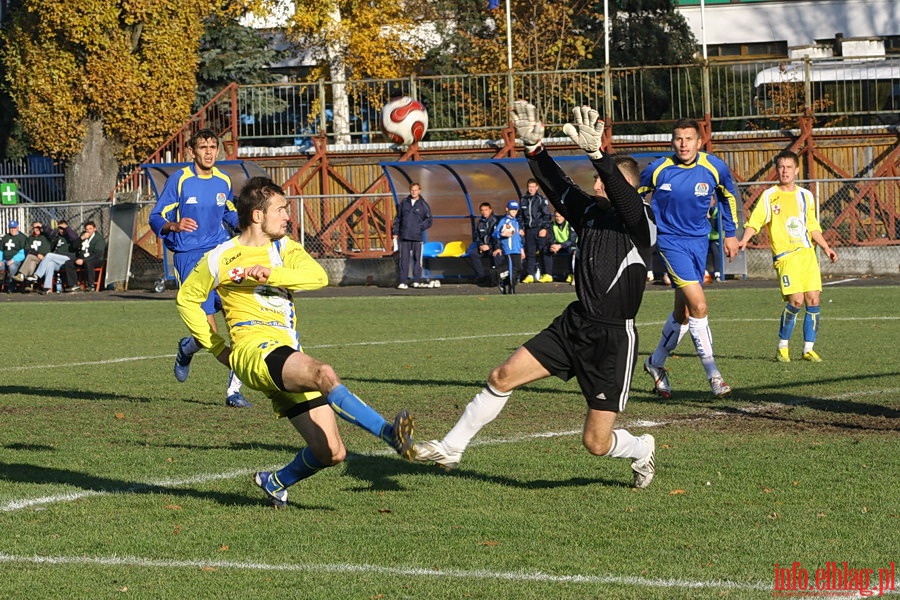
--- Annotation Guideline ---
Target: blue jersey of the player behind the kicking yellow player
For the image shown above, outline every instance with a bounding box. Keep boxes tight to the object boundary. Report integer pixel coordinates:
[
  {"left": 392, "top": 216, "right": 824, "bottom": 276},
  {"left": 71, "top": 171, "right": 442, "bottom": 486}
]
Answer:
[{"left": 150, "top": 165, "right": 238, "bottom": 252}]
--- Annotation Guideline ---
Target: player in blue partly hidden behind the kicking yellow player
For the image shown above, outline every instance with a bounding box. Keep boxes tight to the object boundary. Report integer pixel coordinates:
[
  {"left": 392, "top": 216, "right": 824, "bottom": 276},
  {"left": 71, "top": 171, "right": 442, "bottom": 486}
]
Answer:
[{"left": 150, "top": 129, "right": 251, "bottom": 408}]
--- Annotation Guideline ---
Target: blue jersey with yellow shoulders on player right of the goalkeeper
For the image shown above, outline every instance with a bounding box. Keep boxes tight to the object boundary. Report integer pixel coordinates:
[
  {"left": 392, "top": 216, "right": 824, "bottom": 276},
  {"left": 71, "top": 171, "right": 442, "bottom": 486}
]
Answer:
[{"left": 638, "top": 152, "right": 739, "bottom": 238}]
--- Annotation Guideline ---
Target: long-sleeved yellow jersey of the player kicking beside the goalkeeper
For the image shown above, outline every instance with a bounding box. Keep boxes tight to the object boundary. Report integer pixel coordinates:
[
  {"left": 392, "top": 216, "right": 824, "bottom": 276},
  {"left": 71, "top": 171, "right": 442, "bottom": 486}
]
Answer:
[{"left": 176, "top": 237, "right": 328, "bottom": 356}]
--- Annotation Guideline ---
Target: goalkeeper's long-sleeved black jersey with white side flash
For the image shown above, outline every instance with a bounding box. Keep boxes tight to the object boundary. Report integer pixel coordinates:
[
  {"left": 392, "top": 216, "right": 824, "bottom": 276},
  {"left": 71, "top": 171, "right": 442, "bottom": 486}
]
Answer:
[{"left": 528, "top": 150, "right": 656, "bottom": 321}]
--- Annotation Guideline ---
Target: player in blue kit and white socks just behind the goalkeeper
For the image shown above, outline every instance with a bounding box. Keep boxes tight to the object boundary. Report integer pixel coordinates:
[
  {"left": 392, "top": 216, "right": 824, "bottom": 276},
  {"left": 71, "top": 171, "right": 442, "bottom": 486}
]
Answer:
[{"left": 638, "top": 119, "right": 739, "bottom": 398}]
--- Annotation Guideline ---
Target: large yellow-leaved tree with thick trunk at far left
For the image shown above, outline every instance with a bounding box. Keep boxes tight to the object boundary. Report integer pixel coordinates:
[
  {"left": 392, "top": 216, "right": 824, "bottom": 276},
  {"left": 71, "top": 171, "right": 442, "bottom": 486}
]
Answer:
[{"left": 2, "top": 0, "right": 239, "bottom": 201}]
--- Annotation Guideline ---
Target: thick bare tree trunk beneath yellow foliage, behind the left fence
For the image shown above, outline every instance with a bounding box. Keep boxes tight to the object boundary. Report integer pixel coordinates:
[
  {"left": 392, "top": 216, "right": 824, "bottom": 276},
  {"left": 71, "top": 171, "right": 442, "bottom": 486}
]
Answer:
[{"left": 66, "top": 121, "right": 119, "bottom": 202}]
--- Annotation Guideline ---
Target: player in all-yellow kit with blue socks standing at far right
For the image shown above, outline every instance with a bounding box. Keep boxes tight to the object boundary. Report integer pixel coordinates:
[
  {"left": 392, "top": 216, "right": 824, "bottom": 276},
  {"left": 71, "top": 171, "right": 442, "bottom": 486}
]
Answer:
[{"left": 738, "top": 150, "right": 837, "bottom": 362}]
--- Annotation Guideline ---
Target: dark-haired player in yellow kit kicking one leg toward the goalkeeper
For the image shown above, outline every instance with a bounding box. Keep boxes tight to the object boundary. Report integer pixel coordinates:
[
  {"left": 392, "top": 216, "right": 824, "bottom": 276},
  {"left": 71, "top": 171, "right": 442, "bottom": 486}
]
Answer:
[{"left": 177, "top": 177, "right": 414, "bottom": 508}]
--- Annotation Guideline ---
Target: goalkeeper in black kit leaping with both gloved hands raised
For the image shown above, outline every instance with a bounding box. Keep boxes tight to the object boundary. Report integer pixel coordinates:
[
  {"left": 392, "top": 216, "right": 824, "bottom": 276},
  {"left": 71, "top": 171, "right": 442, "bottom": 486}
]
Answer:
[{"left": 415, "top": 100, "right": 656, "bottom": 488}]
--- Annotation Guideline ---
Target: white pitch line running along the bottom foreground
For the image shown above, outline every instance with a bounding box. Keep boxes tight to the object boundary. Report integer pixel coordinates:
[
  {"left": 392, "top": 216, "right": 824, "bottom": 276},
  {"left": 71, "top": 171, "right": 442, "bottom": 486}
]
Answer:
[{"left": 0, "top": 553, "right": 772, "bottom": 590}]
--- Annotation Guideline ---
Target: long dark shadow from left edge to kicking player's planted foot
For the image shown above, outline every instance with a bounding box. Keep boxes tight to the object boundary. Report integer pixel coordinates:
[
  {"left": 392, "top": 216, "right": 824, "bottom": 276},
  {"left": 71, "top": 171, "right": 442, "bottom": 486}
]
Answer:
[{"left": 0, "top": 463, "right": 333, "bottom": 510}]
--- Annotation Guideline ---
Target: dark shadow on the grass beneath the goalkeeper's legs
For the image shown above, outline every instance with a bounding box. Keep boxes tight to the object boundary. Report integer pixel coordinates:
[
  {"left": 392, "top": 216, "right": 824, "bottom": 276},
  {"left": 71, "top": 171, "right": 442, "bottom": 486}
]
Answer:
[{"left": 344, "top": 454, "right": 631, "bottom": 492}]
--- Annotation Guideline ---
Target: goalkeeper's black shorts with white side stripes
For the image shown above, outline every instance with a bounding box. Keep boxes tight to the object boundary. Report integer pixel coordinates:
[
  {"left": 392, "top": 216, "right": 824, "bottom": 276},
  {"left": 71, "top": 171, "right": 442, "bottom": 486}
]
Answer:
[{"left": 523, "top": 302, "right": 638, "bottom": 412}]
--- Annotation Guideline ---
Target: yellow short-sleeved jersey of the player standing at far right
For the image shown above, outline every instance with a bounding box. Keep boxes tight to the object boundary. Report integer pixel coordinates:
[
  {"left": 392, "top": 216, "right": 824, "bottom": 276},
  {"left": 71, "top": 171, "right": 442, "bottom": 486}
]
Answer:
[{"left": 745, "top": 185, "right": 822, "bottom": 258}]
